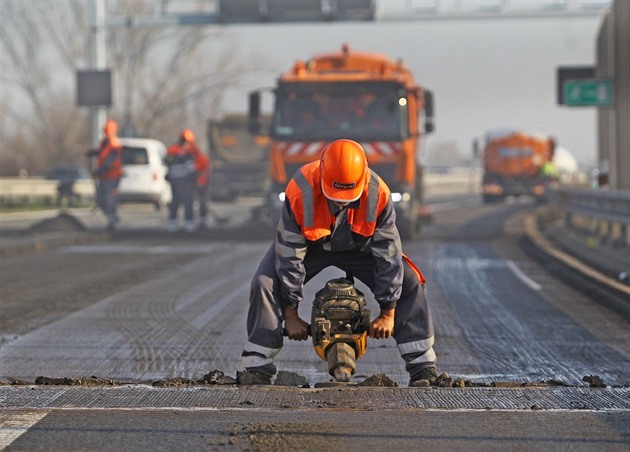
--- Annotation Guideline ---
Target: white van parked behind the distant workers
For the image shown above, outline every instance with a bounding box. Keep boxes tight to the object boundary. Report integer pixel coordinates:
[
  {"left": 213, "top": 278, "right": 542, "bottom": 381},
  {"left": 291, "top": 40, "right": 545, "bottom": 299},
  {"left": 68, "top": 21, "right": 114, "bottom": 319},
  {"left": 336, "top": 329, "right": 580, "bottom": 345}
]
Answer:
[{"left": 118, "top": 138, "right": 172, "bottom": 210}]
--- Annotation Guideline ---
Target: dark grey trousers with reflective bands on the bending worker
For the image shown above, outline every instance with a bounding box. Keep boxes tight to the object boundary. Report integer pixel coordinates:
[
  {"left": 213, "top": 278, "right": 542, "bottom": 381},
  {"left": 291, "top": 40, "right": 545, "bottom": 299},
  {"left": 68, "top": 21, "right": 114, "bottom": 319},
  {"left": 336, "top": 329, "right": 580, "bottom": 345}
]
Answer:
[{"left": 243, "top": 244, "right": 436, "bottom": 378}]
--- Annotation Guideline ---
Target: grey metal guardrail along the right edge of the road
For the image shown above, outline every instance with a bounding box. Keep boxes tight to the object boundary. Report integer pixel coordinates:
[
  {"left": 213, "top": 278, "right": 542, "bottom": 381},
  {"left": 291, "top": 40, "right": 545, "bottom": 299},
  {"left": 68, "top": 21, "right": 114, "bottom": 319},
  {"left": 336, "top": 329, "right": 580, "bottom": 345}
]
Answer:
[{"left": 549, "top": 189, "right": 630, "bottom": 247}]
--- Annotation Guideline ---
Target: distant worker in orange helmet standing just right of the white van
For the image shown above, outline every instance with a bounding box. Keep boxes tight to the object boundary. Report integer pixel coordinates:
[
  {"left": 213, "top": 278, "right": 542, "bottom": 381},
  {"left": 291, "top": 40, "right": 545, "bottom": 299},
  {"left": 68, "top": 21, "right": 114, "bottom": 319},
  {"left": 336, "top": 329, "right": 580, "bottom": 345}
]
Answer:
[{"left": 166, "top": 129, "right": 200, "bottom": 232}]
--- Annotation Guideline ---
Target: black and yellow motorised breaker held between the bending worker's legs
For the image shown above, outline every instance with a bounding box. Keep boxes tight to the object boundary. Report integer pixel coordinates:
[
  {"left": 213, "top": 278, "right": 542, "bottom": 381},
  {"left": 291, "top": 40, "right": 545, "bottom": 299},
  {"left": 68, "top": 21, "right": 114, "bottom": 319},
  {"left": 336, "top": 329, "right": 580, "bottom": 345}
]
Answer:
[{"left": 311, "top": 274, "right": 370, "bottom": 382}]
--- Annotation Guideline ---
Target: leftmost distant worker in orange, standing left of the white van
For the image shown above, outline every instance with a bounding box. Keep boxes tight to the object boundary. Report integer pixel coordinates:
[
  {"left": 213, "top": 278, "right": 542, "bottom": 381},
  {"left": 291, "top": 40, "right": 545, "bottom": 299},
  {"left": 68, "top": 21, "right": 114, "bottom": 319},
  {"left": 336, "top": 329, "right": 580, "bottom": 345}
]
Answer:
[{"left": 93, "top": 119, "right": 122, "bottom": 230}]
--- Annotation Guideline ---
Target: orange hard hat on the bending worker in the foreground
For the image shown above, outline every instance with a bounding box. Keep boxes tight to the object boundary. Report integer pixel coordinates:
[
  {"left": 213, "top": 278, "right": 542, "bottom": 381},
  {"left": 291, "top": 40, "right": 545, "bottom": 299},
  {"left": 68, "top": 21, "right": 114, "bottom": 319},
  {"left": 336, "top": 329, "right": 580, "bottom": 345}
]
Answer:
[{"left": 320, "top": 140, "right": 368, "bottom": 202}]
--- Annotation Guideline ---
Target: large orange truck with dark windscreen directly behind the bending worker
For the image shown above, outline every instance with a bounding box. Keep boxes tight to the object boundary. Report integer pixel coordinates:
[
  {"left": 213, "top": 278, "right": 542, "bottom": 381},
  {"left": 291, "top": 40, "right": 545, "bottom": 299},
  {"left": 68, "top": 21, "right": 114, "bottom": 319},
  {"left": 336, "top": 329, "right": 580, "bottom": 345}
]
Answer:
[{"left": 249, "top": 44, "right": 433, "bottom": 239}]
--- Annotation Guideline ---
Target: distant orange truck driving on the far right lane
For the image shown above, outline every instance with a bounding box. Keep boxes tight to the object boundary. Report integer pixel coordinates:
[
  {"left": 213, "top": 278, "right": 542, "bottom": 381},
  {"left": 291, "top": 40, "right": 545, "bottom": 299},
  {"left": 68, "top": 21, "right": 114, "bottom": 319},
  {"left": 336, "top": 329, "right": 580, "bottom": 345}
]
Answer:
[{"left": 473, "top": 130, "right": 556, "bottom": 202}]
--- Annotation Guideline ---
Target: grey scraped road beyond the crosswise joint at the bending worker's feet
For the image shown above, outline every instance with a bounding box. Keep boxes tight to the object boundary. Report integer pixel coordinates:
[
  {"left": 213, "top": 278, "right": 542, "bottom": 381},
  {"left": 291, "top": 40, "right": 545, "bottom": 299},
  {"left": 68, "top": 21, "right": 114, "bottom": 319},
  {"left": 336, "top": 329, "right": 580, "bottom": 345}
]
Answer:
[{"left": 0, "top": 202, "right": 630, "bottom": 386}]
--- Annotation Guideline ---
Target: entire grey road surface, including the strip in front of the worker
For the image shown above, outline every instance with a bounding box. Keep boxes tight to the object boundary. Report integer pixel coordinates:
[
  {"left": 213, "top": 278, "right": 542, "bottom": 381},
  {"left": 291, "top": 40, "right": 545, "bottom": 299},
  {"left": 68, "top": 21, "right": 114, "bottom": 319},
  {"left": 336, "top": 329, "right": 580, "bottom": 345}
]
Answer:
[{"left": 0, "top": 200, "right": 630, "bottom": 450}]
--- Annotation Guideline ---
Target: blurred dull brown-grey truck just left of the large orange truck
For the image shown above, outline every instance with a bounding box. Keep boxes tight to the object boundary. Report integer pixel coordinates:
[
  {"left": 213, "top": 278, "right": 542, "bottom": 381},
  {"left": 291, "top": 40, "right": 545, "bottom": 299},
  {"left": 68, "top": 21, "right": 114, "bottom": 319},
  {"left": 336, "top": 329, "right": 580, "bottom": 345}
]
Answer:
[{"left": 207, "top": 114, "right": 270, "bottom": 202}]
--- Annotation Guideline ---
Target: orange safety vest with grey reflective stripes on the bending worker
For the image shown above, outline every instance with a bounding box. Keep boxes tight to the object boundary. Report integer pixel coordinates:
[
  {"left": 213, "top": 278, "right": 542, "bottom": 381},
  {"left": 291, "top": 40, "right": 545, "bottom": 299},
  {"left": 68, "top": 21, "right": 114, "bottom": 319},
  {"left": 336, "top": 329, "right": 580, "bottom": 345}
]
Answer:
[{"left": 286, "top": 161, "right": 390, "bottom": 241}]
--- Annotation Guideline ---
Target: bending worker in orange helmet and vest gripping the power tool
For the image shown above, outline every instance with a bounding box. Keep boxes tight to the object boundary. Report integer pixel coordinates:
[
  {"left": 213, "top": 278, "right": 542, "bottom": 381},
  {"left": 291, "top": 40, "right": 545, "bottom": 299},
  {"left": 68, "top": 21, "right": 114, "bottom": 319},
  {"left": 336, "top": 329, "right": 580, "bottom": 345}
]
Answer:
[{"left": 242, "top": 140, "right": 436, "bottom": 386}]
